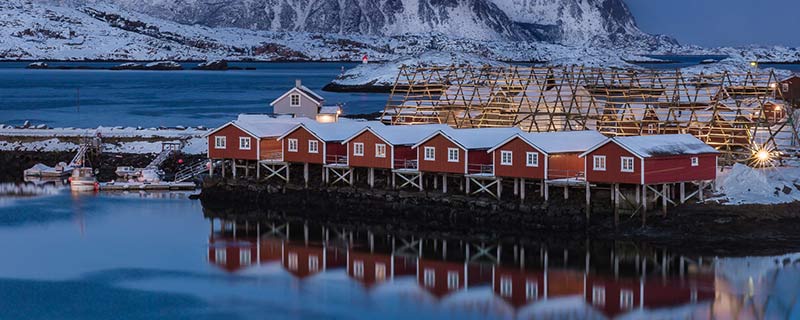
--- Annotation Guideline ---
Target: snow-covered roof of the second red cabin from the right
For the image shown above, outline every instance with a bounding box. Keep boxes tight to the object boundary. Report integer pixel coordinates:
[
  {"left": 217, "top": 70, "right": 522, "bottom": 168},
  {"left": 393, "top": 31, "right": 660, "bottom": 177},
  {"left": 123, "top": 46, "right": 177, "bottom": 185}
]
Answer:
[{"left": 521, "top": 130, "right": 608, "bottom": 154}]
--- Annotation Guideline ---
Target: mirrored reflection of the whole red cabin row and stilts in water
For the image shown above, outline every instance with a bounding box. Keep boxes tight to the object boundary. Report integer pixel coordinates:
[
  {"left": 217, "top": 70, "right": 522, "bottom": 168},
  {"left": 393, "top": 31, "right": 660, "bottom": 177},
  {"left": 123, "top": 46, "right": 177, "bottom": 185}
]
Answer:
[{"left": 207, "top": 219, "right": 800, "bottom": 319}]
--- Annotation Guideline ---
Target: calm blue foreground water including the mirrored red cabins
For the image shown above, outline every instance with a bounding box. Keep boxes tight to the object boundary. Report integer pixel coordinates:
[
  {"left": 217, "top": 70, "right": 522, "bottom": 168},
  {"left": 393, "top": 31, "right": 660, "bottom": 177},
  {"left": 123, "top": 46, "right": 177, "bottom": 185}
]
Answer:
[{"left": 0, "top": 191, "right": 800, "bottom": 319}]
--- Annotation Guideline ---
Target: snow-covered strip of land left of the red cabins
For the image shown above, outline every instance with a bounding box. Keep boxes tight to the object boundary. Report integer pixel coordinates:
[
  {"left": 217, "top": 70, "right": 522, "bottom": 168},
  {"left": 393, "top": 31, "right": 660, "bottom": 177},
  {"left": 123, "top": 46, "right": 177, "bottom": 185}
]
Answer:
[{"left": 0, "top": 126, "right": 209, "bottom": 154}]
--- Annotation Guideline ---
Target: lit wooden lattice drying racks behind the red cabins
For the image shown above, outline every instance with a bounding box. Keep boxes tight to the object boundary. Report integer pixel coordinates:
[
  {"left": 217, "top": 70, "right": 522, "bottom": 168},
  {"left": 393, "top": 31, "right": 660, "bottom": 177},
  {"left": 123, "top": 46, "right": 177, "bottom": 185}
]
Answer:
[{"left": 382, "top": 65, "right": 798, "bottom": 162}]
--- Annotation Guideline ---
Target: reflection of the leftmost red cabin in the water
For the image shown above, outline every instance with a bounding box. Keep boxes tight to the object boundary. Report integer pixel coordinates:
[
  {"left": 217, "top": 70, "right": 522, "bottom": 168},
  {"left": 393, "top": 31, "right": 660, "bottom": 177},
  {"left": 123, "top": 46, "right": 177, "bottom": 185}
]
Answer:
[{"left": 208, "top": 235, "right": 282, "bottom": 272}]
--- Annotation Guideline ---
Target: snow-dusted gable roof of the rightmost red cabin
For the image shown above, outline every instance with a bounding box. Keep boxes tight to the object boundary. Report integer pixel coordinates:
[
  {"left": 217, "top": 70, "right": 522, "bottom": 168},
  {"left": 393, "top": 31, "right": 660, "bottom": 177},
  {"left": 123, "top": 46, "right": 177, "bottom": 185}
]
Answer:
[{"left": 580, "top": 134, "right": 719, "bottom": 158}]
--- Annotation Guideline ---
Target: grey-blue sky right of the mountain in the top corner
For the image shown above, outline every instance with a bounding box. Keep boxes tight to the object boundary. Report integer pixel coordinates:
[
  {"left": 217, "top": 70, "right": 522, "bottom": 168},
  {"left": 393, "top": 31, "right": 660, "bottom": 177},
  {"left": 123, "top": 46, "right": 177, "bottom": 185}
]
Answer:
[{"left": 626, "top": 0, "right": 800, "bottom": 46}]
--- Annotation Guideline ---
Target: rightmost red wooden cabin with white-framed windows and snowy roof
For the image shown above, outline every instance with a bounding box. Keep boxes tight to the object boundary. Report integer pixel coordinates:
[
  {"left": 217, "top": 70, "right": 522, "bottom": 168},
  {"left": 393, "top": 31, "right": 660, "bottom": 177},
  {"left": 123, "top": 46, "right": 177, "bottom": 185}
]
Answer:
[{"left": 581, "top": 134, "right": 719, "bottom": 185}]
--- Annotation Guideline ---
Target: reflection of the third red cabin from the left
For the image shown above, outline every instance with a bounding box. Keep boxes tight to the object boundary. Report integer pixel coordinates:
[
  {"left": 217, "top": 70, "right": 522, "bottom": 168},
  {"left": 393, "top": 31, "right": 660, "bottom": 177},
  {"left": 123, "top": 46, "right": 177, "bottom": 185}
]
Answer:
[{"left": 347, "top": 251, "right": 416, "bottom": 287}]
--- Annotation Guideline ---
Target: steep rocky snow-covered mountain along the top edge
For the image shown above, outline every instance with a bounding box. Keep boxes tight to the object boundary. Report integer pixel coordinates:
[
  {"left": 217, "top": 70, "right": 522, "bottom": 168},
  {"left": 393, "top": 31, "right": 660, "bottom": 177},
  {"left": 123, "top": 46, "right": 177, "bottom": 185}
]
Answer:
[{"left": 36, "top": 0, "right": 675, "bottom": 46}]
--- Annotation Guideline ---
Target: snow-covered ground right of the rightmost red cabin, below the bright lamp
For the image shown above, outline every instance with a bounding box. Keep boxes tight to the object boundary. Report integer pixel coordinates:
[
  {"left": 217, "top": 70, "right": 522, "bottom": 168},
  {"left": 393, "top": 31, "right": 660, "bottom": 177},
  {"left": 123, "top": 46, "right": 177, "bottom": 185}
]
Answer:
[{"left": 709, "top": 164, "right": 800, "bottom": 205}]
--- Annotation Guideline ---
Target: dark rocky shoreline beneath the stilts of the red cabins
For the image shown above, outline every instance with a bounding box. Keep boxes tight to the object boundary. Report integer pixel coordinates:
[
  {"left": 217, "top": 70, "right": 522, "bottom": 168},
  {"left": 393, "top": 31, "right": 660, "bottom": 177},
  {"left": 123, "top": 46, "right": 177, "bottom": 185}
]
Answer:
[{"left": 198, "top": 179, "right": 800, "bottom": 255}]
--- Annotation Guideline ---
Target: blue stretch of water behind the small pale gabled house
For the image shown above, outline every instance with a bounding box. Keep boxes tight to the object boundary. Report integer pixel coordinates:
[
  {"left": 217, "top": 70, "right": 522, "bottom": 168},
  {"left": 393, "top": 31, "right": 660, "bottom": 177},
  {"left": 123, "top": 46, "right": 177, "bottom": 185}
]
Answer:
[{"left": 0, "top": 62, "right": 387, "bottom": 127}]
